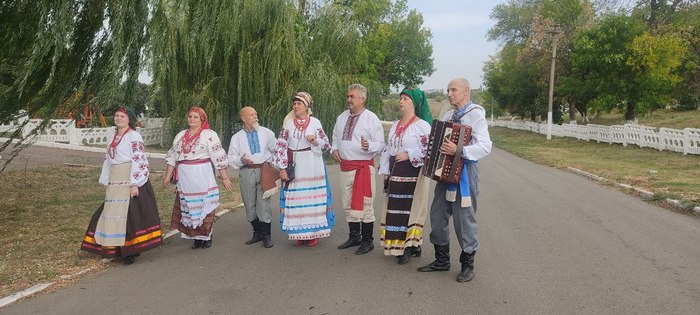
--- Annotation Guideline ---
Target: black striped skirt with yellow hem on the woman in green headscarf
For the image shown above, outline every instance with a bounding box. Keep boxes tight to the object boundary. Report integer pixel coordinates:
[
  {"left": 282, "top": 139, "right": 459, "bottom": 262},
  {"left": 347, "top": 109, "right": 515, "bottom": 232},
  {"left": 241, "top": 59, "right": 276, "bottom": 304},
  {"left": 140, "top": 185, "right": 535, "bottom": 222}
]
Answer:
[{"left": 379, "top": 161, "right": 430, "bottom": 256}]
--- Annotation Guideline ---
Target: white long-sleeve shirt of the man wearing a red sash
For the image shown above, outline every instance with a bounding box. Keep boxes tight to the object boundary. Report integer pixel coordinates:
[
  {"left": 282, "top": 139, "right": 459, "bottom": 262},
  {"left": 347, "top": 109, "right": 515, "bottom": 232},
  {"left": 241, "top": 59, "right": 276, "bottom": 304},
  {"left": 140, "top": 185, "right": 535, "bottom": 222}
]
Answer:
[{"left": 331, "top": 109, "right": 385, "bottom": 161}]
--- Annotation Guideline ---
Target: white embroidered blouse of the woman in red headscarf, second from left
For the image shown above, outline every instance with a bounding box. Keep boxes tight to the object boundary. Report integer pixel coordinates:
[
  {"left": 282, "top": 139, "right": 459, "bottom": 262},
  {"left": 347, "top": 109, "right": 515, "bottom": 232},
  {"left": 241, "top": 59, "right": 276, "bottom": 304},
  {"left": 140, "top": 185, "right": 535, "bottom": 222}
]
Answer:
[{"left": 165, "top": 129, "right": 228, "bottom": 170}]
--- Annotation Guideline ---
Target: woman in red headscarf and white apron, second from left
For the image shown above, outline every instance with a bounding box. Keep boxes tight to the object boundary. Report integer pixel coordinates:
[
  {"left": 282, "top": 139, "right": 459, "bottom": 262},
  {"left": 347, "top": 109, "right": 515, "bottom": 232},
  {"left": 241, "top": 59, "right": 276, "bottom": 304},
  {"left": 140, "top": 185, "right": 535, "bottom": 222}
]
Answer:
[{"left": 163, "top": 107, "right": 231, "bottom": 249}]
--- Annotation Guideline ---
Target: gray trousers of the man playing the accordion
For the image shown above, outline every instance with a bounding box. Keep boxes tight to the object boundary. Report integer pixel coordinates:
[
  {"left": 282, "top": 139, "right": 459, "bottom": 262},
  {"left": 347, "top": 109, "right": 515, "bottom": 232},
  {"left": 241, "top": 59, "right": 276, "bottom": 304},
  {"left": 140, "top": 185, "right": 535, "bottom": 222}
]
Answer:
[{"left": 430, "top": 163, "right": 479, "bottom": 254}]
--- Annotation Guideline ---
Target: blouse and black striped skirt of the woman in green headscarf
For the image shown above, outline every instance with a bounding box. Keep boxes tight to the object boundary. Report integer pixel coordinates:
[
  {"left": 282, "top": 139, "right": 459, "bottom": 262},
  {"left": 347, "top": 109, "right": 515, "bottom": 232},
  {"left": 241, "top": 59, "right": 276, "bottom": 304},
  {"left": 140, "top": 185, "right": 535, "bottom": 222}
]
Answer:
[{"left": 379, "top": 116, "right": 430, "bottom": 256}]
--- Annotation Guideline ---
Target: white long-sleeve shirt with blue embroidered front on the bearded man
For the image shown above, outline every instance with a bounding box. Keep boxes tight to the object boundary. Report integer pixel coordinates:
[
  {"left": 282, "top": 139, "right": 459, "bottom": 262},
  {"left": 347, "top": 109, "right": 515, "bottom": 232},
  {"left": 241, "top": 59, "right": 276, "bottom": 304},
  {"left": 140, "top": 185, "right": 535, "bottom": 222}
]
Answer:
[{"left": 228, "top": 127, "right": 277, "bottom": 170}]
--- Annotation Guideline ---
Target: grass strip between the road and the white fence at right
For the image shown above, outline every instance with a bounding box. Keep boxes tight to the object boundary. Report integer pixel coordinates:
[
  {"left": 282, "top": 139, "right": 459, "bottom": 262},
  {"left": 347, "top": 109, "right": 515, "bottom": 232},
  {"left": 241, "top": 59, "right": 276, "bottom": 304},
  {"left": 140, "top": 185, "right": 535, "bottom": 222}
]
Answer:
[{"left": 489, "top": 127, "right": 700, "bottom": 207}]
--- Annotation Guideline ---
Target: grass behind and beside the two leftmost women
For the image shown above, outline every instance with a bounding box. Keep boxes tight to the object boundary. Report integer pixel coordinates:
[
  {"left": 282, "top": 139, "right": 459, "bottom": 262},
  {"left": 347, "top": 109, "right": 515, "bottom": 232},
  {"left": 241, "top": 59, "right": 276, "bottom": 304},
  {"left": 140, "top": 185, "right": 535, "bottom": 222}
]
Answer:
[{"left": 0, "top": 167, "right": 241, "bottom": 297}]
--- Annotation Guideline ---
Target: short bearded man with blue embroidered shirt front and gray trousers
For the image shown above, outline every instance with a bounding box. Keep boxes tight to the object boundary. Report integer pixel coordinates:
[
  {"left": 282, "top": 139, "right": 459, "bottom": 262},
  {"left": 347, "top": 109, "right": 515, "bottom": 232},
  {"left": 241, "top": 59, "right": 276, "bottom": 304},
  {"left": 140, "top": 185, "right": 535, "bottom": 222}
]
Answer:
[{"left": 228, "top": 106, "right": 277, "bottom": 248}]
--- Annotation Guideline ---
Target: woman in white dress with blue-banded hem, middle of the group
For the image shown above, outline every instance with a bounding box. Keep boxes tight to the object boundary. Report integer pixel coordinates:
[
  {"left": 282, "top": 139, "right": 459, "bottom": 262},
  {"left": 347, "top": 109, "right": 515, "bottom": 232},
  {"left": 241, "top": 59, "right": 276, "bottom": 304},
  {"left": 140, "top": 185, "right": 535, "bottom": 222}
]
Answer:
[{"left": 273, "top": 92, "right": 335, "bottom": 246}]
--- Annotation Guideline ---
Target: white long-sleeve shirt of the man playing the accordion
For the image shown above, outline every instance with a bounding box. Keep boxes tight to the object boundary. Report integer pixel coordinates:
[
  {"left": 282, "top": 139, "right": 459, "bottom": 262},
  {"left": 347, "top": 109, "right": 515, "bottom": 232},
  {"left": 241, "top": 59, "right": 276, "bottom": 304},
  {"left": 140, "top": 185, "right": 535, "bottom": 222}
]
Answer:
[{"left": 442, "top": 103, "right": 492, "bottom": 161}]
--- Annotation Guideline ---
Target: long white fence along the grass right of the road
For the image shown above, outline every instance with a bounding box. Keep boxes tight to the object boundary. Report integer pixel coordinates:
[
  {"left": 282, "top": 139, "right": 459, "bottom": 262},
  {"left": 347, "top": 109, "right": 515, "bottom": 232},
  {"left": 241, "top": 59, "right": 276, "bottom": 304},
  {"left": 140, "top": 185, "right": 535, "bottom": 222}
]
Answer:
[{"left": 489, "top": 120, "right": 700, "bottom": 154}]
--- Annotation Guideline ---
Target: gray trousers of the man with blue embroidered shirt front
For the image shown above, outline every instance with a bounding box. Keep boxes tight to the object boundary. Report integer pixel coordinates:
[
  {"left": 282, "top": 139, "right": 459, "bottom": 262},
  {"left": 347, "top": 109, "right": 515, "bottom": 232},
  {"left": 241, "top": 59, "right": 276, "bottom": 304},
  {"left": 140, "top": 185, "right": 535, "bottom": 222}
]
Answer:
[{"left": 238, "top": 167, "right": 272, "bottom": 223}]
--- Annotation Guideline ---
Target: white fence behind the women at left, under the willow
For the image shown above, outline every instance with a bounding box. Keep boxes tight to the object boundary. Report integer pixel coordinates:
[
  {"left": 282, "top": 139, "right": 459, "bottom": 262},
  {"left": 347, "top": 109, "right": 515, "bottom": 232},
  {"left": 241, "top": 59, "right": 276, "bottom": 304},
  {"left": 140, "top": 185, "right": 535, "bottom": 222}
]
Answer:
[{"left": 0, "top": 117, "right": 164, "bottom": 145}]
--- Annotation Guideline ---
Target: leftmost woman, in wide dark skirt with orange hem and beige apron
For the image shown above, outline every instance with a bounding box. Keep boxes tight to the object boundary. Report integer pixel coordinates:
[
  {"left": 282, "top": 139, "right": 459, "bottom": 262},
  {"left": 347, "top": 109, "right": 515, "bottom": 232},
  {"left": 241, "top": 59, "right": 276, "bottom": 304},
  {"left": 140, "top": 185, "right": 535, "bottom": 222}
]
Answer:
[{"left": 81, "top": 107, "right": 162, "bottom": 265}]
